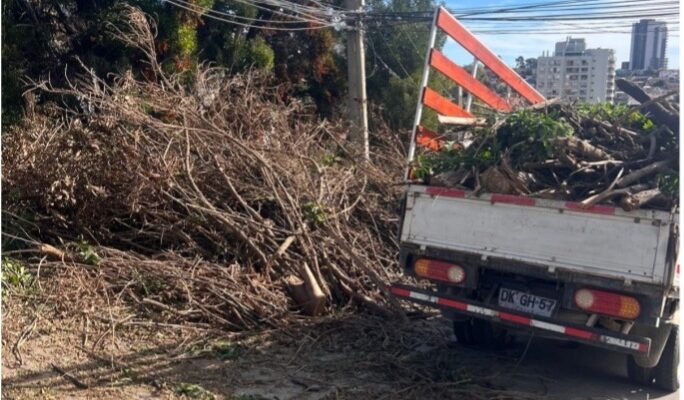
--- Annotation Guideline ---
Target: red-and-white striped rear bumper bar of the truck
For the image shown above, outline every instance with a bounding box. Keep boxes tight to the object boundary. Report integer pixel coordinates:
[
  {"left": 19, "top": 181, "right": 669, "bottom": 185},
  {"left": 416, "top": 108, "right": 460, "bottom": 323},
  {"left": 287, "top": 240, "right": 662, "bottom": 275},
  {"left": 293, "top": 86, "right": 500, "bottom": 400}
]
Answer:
[{"left": 391, "top": 284, "right": 651, "bottom": 355}]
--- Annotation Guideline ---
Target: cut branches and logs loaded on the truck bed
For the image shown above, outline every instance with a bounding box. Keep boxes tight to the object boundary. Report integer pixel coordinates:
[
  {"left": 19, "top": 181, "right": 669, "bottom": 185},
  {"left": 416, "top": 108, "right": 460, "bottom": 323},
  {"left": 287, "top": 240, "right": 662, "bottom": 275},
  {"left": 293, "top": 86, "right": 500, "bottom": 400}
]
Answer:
[{"left": 413, "top": 90, "right": 679, "bottom": 211}]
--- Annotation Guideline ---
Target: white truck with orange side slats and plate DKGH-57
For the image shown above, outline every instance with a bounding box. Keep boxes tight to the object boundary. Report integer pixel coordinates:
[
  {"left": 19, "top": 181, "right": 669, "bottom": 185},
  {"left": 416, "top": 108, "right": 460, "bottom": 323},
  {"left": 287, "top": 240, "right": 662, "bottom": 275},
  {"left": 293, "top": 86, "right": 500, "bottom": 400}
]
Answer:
[{"left": 391, "top": 9, "right": 679, "bottom": 391}]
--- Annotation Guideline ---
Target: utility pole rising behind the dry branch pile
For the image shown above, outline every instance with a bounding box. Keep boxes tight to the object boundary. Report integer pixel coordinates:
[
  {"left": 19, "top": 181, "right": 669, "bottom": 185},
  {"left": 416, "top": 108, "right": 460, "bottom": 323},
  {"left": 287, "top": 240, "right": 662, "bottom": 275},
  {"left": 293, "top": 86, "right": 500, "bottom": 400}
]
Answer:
[{"left": 344, "top": 0, "right": 370, "bottom": 160}]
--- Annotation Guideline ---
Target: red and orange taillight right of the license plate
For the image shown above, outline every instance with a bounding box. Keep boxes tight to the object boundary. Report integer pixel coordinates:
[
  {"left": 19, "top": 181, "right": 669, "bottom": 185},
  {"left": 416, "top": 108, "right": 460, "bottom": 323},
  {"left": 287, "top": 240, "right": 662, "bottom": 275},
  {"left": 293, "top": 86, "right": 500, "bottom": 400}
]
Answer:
[{"left": 575, "top": 289, "right": 641, "bottom": 319}]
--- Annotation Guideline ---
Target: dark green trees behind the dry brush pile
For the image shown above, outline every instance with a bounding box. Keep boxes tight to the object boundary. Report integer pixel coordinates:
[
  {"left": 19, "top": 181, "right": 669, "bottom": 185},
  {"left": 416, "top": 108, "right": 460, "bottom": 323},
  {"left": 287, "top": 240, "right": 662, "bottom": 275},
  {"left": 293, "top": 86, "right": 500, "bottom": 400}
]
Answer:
[{"left": 2, "top": 0, "right": 438, "bottom": 129}]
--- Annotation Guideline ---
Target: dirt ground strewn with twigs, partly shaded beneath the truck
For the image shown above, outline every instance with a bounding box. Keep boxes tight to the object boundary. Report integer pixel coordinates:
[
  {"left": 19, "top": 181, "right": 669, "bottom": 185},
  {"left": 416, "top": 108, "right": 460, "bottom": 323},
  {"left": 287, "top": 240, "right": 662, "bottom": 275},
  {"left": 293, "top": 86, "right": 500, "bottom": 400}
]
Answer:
[{"left": 2, "top": 294, "right": 677, "bottom": 400}]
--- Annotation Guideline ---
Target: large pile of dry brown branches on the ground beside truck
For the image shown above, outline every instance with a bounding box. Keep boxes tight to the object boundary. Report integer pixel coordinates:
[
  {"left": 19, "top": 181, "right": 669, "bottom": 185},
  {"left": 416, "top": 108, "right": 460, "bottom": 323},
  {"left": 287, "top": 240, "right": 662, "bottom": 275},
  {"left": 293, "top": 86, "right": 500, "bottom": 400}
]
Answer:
[{"left": 2, "top": 8, "right": 403, "bottom": 329}]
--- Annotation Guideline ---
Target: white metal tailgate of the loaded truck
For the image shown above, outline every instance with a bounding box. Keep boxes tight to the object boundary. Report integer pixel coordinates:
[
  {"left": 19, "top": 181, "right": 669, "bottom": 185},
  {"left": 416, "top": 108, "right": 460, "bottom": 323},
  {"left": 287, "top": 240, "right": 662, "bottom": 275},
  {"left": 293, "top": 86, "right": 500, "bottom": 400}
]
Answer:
[{"left": 401, "top": 185, "right": 673, "bottom": 285}]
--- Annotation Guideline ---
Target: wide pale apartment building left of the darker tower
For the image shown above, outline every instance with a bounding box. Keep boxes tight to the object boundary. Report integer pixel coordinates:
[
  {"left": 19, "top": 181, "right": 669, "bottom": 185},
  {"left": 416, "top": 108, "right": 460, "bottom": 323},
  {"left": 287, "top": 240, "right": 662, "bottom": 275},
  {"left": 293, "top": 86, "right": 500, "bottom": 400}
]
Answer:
[{"left": 536, "top": 38, "right": 615, "bottom": 103}]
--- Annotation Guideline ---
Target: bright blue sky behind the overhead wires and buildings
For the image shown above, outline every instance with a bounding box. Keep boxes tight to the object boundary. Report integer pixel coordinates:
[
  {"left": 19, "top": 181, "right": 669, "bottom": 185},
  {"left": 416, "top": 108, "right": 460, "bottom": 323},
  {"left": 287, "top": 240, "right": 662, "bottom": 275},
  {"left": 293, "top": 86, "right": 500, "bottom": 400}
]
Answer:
[{"left": 444, "top": 0, "right": 679, "bottom": 69}]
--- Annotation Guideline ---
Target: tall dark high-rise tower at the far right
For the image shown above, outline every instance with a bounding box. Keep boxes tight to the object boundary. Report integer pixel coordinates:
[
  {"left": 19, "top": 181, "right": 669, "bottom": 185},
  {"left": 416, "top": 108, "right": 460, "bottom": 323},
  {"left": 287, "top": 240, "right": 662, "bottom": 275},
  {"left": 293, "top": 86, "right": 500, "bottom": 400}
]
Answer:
[{"left": 629, "top": 19, "right": 667, "bottom": 71}]
